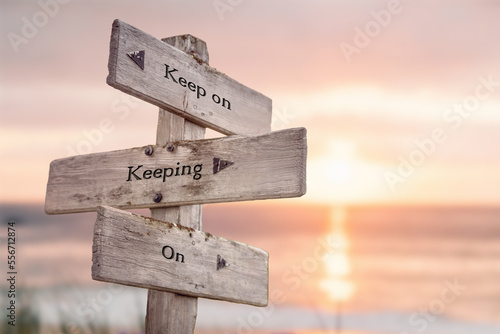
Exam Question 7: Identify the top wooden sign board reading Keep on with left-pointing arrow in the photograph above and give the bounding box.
[107,20,272,135]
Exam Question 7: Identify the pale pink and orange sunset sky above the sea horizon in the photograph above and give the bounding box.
[0,0,500,204]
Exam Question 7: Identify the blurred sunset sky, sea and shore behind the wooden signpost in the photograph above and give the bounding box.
[0,0,500,334]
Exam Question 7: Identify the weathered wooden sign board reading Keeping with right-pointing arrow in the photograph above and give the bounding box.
[45,128,307,214]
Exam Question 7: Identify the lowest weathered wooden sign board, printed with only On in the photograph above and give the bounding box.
[92,207,269,306]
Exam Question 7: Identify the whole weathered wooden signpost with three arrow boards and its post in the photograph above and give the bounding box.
[45,20,307,334]
